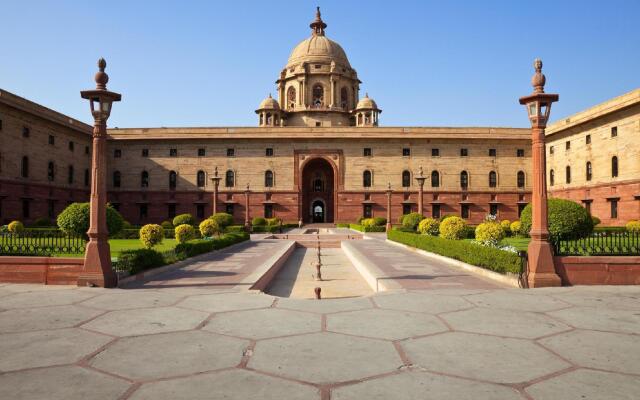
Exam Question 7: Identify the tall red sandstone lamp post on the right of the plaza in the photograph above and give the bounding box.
[520,59,562,287]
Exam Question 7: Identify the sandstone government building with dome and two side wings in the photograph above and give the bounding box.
[0,11,640,225]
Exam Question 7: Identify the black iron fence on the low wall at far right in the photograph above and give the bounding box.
[552,231,640,256]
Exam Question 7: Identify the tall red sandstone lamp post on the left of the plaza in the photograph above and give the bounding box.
[78,58,122,287]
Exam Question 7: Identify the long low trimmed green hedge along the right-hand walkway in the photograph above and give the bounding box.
[387,230,521,274]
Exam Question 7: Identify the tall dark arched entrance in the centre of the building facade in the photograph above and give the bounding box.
[301,158,335,223]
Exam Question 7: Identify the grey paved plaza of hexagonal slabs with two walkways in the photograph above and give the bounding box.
[0,236,640,400]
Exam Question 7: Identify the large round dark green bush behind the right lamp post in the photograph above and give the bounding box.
[520,199,593,239]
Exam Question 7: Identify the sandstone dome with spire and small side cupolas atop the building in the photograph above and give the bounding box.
[256,7,381,126]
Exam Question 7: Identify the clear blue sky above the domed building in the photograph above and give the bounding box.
[0,0,640,127]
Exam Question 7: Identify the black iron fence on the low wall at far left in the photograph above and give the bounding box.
[0,230,87,256]
